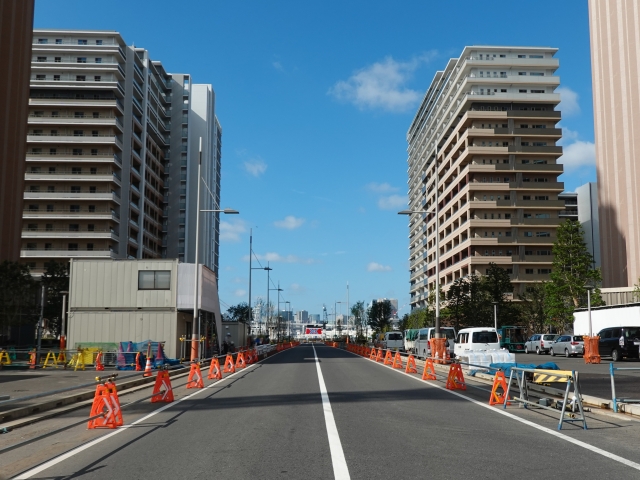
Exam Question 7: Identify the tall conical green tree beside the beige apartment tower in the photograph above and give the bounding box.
[545,220,604,332]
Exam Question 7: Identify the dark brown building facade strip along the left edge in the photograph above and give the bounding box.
[0,0,35,262]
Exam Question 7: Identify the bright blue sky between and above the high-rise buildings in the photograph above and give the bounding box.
[35,0,595,320]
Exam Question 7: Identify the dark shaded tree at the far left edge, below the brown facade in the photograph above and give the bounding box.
[0,260,38,341]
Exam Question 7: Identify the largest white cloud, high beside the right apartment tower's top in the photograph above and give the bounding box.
[328,53,435,112]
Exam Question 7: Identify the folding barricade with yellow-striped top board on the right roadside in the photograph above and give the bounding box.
[503,367,587,430]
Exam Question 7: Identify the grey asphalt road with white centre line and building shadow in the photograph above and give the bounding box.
[0,346,640,480]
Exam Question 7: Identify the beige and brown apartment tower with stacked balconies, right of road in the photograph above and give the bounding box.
[407,46,564,308]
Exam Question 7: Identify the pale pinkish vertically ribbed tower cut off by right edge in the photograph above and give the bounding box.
[589,0,640,287]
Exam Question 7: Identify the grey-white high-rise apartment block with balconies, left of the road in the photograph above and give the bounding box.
[21,30,220,275]
